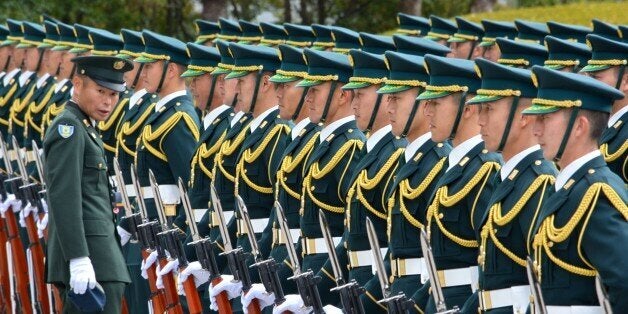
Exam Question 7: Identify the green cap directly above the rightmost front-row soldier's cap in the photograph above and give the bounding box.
[544,35,591,72]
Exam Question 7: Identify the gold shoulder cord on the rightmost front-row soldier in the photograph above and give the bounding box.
[533,182,628,277]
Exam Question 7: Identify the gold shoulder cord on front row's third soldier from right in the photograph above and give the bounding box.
[427,162,500,248]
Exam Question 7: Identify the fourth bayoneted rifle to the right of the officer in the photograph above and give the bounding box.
[170,178,203,314]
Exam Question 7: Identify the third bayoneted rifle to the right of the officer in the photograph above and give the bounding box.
[148,169,183,314]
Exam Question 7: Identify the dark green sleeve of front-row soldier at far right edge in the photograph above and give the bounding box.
[580,193,628,313]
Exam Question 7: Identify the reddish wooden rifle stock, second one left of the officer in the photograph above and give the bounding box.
[5,206,33,314]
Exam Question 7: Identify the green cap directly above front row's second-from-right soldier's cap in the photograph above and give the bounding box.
[495,38,548,69]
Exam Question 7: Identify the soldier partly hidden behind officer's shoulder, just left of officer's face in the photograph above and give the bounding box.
[41,22,76,134]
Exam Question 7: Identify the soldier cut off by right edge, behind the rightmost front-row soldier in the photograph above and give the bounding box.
[581,34,628,183]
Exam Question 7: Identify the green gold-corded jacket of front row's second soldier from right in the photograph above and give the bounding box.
[478,149,556,290]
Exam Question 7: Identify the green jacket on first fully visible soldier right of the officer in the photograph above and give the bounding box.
[135,95,200,222]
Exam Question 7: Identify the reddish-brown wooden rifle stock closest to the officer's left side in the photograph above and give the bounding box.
[24,215,50,313]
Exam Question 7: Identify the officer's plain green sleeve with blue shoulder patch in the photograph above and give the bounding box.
[44,119,89,261]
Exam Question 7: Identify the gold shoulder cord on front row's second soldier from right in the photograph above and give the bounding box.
[478,174,555,267]
